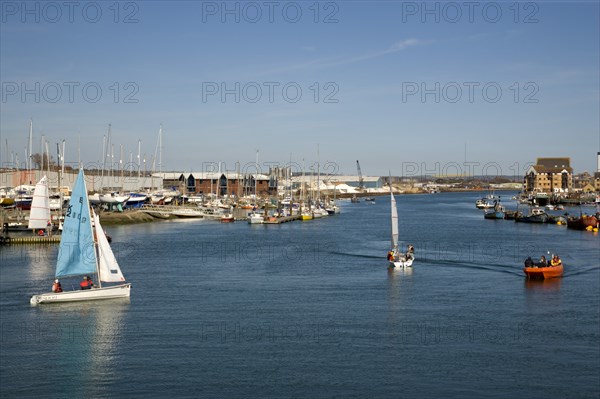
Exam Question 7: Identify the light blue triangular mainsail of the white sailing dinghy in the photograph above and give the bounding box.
[55,169,97,277]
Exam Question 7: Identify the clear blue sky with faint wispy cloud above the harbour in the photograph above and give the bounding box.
[0,1,600,176]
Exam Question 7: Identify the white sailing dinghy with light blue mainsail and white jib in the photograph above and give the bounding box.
[30,169,131,305]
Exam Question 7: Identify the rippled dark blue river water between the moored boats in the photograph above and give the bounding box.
[0,193,600,398]
